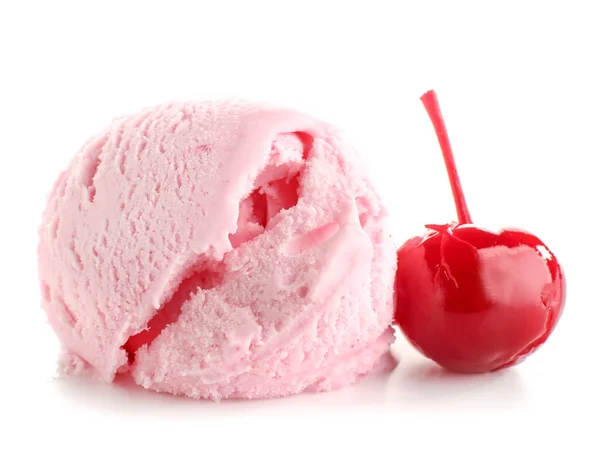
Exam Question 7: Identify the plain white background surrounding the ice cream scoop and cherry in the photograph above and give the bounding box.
[0,0,600,461]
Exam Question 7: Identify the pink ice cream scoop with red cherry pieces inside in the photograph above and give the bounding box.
[39,102,396,400]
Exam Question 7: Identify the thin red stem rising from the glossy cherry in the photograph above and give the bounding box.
[421,90,472,225]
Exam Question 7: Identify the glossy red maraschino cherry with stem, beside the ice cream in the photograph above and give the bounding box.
[395,91,566,373]
